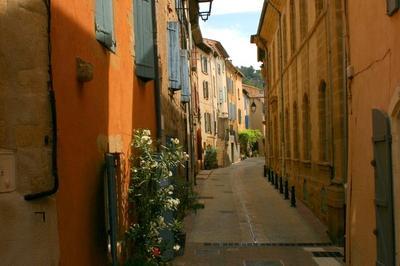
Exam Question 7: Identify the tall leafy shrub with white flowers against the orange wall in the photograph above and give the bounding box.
[127,129,189,265]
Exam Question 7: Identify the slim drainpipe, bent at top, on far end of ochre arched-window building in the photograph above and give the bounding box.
[268,1,287,180]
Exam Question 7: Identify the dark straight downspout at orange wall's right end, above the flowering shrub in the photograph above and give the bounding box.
[151,0,162,144]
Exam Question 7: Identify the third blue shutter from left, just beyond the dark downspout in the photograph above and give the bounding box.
[168,21,181,90]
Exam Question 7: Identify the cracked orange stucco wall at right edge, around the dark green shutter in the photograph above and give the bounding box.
[347,0,400,265]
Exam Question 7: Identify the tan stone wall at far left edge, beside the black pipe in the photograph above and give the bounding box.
[0,0,59,265]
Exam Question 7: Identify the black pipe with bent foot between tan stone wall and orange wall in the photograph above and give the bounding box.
[24,0,59,201]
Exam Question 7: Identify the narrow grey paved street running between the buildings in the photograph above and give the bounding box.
[174,158,343,266]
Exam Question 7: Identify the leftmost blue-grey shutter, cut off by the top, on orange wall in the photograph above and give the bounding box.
[95,0,115,52]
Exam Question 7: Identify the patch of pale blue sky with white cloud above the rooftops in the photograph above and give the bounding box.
[200,0,264,69]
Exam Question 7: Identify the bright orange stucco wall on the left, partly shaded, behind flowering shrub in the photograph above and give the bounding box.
[51,0,155,265]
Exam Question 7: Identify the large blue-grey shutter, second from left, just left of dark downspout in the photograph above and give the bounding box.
[134,0,155,79]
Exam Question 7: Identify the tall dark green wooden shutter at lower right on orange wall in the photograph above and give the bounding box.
[372,109,395,266]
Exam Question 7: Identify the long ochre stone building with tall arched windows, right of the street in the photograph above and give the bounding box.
[252,0,347,244]
